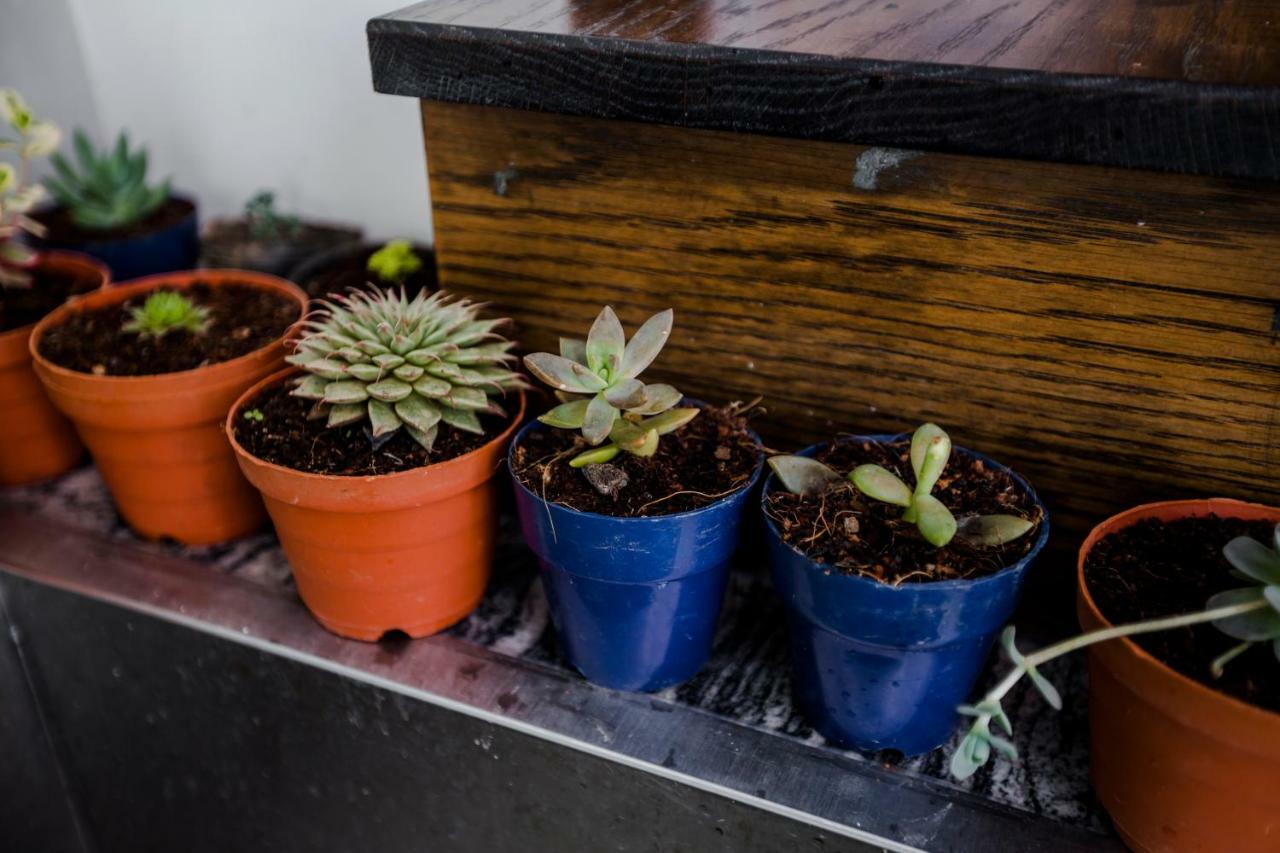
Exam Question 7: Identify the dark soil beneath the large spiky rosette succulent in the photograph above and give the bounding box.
[236,379,511,476]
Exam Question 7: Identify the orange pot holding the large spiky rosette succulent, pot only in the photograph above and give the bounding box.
[227,369,525,640]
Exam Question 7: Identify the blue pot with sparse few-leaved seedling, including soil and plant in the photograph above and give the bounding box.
[763,424,1048,756]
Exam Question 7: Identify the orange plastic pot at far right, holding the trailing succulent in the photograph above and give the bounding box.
[1076,498,1280,853]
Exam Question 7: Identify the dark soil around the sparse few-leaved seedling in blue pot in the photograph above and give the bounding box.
[765,439,1041,585]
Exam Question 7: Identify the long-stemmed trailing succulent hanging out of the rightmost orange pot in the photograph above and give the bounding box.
[951,517,1280,779]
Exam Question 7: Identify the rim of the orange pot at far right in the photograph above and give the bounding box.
[1075,498,1280,725]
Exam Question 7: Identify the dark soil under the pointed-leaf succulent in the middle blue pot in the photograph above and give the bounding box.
[515,406,762,517]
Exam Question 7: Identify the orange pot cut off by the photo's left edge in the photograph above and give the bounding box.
[0,252,110,485]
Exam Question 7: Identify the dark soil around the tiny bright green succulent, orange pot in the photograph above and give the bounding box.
[40,282,300,377]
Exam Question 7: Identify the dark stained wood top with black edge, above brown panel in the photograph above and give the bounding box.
[369,0,1280,178]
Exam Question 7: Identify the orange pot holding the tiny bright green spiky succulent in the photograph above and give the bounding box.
[31,269,307,544]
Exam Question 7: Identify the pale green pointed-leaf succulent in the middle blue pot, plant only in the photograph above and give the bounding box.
[525,306,698,467]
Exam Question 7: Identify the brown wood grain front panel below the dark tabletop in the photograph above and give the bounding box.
[424,104,1280,571]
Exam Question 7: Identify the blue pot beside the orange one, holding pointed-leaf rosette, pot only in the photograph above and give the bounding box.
[508,421,763,692]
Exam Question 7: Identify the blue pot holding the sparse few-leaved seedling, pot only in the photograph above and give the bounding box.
[762,435,1048,756]
